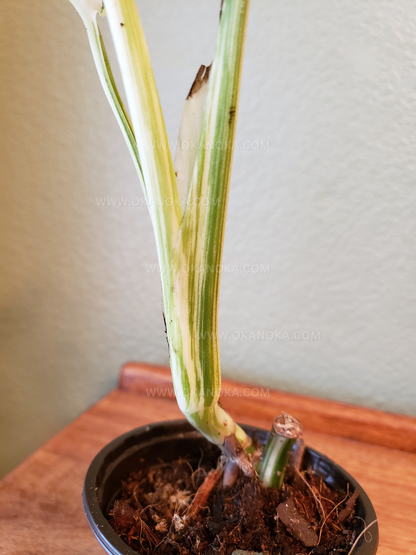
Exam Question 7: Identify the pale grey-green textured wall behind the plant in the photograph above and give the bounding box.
[0,0,416,478]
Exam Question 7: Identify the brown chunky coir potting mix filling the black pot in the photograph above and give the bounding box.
[108,450,363,555]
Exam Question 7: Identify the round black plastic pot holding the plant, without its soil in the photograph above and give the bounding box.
[83,420,378,555]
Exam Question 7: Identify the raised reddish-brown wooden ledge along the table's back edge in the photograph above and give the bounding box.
[120,362,416,456]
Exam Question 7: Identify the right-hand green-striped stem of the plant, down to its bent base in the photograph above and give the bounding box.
[167,0,250,452]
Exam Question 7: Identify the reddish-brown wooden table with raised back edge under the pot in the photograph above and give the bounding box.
[0,363,416,555]
